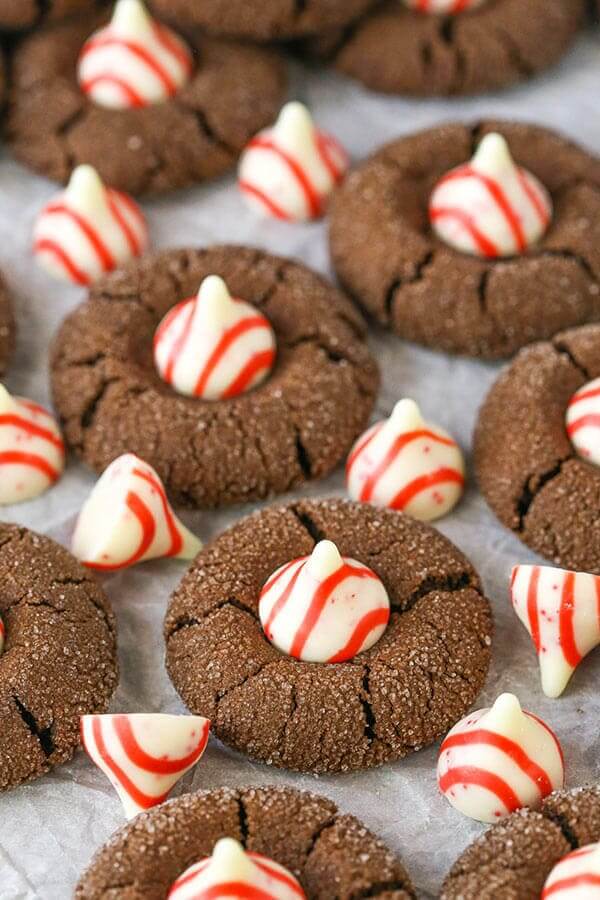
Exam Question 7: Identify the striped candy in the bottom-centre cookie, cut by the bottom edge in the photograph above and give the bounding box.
[169,838,306,900]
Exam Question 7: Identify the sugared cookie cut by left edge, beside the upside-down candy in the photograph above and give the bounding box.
[0,523,117,790]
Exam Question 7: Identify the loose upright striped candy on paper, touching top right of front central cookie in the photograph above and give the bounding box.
[346,400,465,522]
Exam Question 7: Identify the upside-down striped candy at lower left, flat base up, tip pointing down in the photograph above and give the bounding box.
[81,713,210,819]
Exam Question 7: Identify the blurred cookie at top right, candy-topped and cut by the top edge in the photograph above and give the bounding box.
[308,0,585,96]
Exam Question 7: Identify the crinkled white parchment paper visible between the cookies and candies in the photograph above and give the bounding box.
[0,32,600,900]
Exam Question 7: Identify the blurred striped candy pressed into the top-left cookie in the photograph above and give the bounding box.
[77,0,193,109]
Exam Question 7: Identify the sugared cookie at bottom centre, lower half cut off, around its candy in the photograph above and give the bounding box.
[75,787,416,900]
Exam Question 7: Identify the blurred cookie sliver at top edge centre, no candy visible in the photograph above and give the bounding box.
[152,0,375,41]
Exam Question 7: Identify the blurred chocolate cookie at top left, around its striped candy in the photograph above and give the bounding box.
[7,16,286,194]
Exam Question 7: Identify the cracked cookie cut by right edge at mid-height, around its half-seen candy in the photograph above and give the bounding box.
[475,325,600,575]
